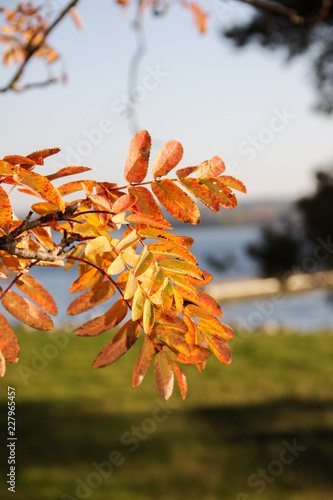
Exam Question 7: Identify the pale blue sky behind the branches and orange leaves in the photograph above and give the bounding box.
[0,0,333,208]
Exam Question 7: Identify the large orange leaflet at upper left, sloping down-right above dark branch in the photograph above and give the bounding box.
[13,167,65,212]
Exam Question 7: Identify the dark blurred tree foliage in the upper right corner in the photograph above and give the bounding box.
[223,0,333,113]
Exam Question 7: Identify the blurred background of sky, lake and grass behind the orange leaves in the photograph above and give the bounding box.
[0,0,333,500]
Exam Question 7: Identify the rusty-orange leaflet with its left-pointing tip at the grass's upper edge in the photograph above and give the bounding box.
[74,297,127,337]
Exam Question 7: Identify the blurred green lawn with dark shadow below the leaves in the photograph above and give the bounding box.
[0,330,333,500]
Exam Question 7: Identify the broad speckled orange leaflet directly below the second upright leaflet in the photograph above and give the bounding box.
[151,179,200,224]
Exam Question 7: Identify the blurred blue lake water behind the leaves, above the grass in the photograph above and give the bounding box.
[6,225,333,332]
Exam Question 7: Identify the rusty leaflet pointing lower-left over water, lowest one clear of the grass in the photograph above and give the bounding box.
[67,281,116,315]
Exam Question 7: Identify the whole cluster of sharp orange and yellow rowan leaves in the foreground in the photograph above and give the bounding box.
[0,131,246,398]
